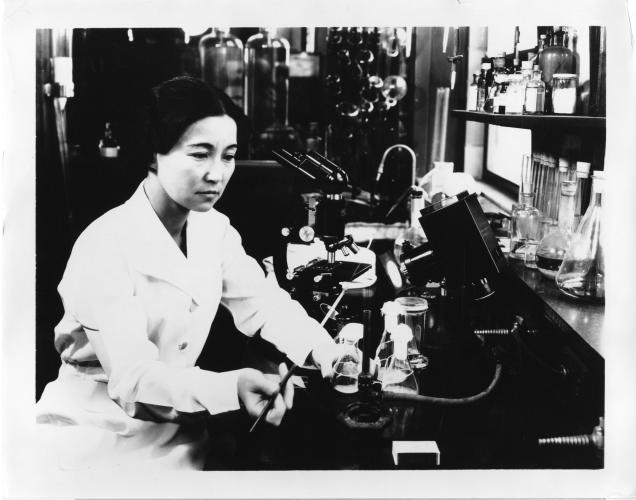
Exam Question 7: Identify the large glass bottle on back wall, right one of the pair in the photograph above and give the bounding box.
[245,28,298,157]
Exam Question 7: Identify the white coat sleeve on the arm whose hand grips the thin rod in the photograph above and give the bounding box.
[59,230,241,421]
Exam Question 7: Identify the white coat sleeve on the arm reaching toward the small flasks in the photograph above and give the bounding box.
[222,222,333,365]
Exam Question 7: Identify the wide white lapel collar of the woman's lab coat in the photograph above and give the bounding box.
[124,181,218,305]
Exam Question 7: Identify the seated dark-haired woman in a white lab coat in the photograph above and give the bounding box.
[37,77,337,469]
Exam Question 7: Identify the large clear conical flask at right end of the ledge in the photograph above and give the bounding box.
[556,176,605,302]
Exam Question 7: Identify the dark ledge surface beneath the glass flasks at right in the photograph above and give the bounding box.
[510,261,605,357]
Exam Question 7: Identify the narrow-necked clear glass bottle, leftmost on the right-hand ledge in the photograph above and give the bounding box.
[508,155,541,267]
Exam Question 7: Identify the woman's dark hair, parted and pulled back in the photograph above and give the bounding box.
[146,76,247,169]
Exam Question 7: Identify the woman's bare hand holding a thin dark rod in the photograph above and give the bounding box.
[238,363,294,425]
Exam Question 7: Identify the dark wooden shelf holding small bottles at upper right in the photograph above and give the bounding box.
[451,109,605,130]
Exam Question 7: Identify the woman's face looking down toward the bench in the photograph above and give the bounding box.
[157,115,237,212]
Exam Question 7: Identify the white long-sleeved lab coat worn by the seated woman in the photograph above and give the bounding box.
[36,183,333,468]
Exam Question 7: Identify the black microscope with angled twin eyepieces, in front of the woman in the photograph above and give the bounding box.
[272,149,372,328]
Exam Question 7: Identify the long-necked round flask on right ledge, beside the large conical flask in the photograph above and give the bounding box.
[536,168,577,279]
